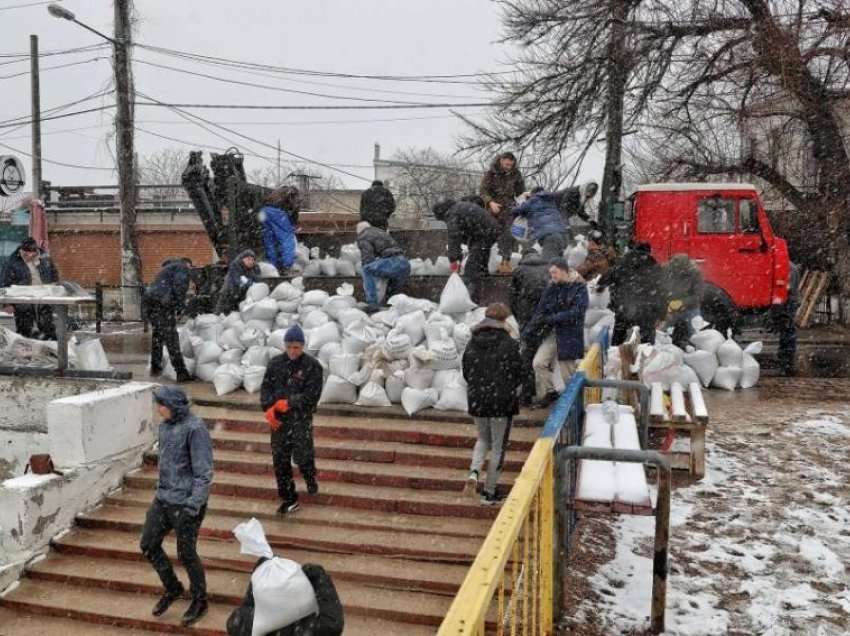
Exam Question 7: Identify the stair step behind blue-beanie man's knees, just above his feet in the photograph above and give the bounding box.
[212,429,526,472]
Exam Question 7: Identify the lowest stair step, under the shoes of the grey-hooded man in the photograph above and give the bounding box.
[0,579,433,636]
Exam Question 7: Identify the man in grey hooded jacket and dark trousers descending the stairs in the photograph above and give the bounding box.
[140,386,213,626]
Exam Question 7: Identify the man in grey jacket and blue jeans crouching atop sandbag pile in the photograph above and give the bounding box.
[357,221,410,313]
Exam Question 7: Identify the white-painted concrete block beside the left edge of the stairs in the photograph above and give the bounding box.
[47,382,157,470]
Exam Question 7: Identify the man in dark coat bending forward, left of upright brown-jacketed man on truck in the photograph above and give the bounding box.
[433,199,501,303]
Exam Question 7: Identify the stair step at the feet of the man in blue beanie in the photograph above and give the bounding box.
[124,468,498,519]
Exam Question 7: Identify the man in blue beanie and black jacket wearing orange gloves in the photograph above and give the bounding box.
[260,325,324,514]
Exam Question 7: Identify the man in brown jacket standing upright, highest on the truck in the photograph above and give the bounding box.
[479,152,525,274]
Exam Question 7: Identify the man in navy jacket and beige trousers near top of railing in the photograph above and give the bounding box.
[522,258,588,408]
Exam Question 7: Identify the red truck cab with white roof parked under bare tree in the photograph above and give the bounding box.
[632,183,790,324]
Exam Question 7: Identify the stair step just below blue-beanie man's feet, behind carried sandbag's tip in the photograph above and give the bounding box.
[77,506,481,564]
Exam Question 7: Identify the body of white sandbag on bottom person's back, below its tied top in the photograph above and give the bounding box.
[251,557,319,636]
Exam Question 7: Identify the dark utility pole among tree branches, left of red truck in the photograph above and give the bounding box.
[599,0,629,237]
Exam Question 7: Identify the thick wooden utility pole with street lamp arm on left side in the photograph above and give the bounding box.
[113,0,142,320]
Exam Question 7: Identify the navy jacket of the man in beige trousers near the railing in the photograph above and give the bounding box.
[522,271,588,360]
